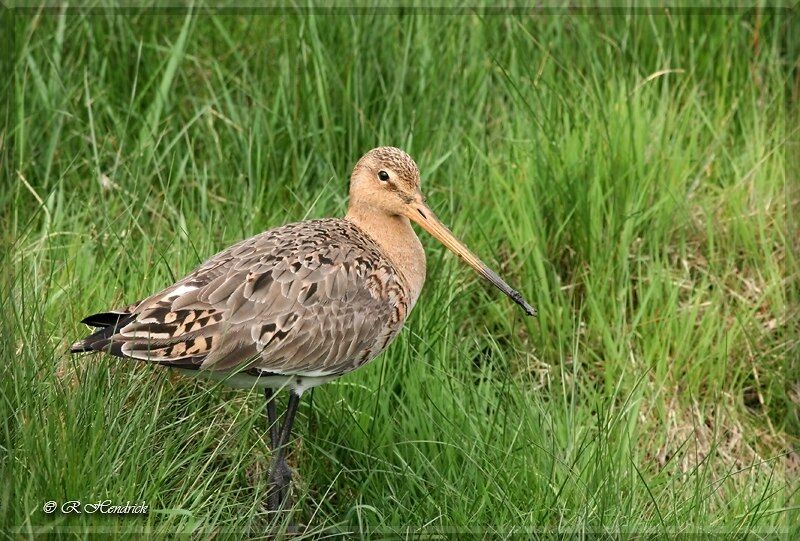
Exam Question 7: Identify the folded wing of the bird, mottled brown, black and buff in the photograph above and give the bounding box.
[90,220,407,375]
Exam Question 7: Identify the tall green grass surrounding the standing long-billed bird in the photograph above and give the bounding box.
[0,4,800,537]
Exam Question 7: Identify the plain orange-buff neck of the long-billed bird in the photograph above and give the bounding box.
[344,205,425,311]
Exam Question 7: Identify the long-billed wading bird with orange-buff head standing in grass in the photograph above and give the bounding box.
[70,146,536,511]
